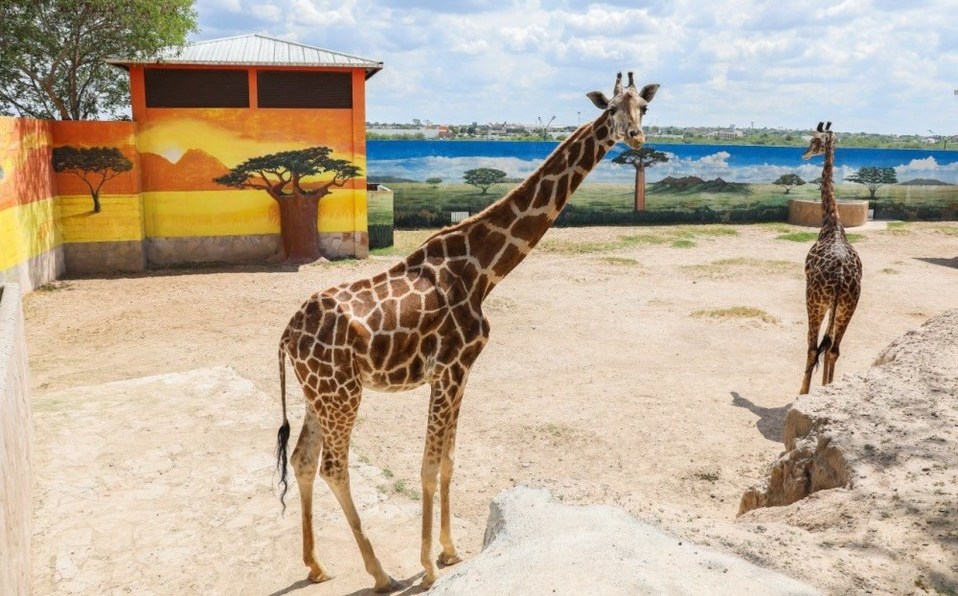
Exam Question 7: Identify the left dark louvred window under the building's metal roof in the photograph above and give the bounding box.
[144,68,249,108]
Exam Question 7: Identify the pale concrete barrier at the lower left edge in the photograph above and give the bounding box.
[0,284,33,594]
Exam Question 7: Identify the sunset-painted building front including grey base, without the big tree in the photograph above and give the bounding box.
[131,67,369,264]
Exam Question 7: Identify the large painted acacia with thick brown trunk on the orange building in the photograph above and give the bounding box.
[213,147,361,261]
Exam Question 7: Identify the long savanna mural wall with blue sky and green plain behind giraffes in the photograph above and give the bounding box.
[366,140,958,229]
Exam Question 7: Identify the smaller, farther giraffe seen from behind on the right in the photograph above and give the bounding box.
[799,122,862,395]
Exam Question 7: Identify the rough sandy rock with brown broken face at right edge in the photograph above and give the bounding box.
[738,310,958,515]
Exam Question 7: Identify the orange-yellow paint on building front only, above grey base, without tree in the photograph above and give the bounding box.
[130,65,367,236]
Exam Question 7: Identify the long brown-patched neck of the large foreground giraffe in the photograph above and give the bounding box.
[424,112,616,298]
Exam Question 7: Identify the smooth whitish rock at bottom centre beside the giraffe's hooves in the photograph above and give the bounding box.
[430,486,818,596]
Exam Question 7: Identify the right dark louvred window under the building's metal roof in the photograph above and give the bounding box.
[256,70,353,108]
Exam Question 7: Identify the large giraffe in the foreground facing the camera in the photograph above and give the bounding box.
[277,72,659,592]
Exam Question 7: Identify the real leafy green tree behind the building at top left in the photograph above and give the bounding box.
[0,0,197,120]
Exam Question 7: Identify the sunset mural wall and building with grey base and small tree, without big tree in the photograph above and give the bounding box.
[0,70,369,291]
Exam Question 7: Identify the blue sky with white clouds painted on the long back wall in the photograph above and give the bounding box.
[366,141,958,184]
